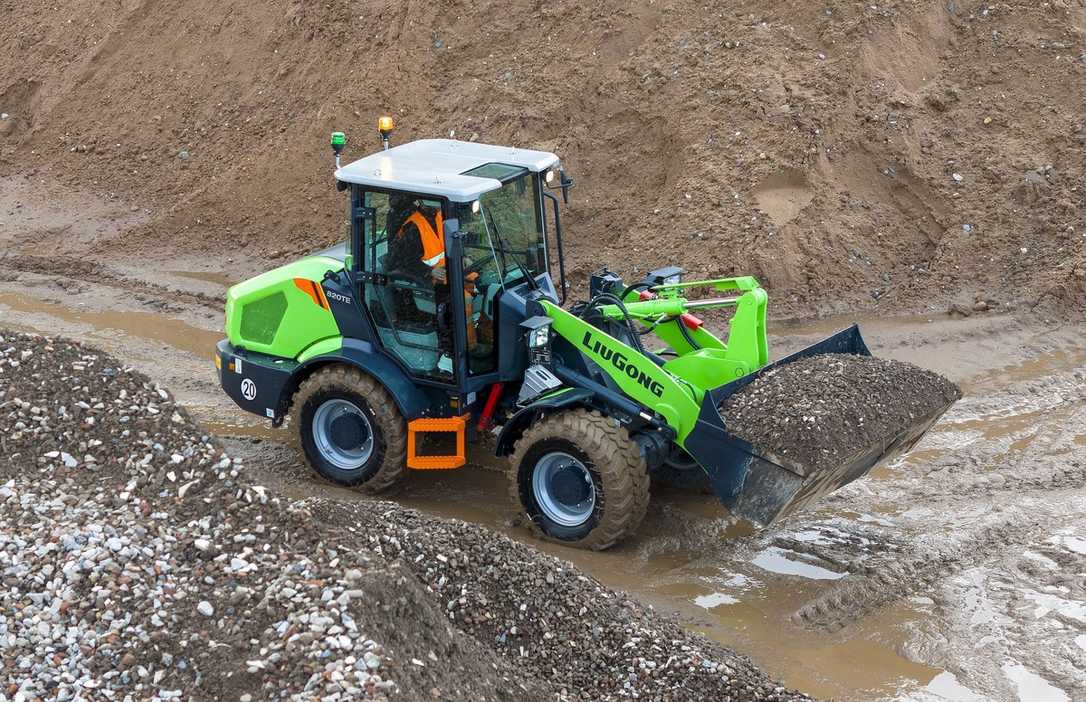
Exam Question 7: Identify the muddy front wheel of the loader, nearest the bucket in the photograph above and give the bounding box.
[509,410,648,551]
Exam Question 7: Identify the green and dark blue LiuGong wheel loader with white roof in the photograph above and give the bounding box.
[215,118,960,549]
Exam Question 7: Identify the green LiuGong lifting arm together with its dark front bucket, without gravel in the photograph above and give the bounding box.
[543,277,949,525]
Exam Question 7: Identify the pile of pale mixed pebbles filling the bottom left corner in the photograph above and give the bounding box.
[0,333,543,701]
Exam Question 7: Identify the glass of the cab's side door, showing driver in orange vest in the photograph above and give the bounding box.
[362,191,455,380]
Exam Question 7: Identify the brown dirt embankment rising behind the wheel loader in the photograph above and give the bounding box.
[0,0,1086,316]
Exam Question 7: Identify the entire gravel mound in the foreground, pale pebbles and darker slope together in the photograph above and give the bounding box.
[0,333,806,701]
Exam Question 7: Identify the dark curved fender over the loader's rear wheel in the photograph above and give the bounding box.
[280,339,432,421]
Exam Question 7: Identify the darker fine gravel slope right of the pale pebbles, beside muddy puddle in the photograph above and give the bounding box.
[303,499,808,701]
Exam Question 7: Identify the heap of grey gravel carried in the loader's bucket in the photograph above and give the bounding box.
[720,353,961,468]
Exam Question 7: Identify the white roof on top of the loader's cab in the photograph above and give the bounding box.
[336,139,558,202]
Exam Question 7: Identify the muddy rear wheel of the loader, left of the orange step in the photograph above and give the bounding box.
[290,365,407,492]
